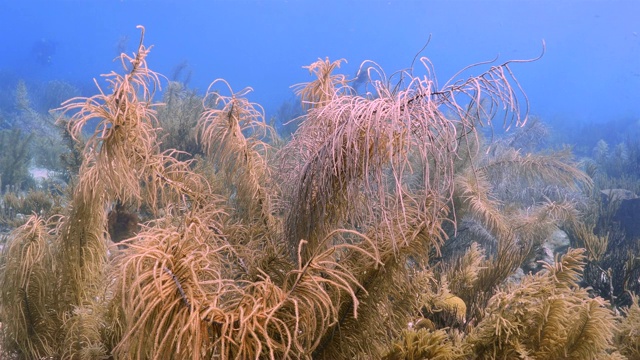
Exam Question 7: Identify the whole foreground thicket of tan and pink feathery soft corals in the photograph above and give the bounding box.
[0,28,639,359]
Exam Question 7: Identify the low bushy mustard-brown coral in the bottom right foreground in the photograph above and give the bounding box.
[467,250,615,359]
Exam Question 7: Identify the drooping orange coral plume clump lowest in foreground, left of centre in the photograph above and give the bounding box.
[112,204,239,359]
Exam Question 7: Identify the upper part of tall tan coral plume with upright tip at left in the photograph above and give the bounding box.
[61,28,164,208]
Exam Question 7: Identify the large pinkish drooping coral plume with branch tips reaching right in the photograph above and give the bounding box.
[281,50,532,262]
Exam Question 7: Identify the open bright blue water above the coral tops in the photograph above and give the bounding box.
[0,0,640,129]
